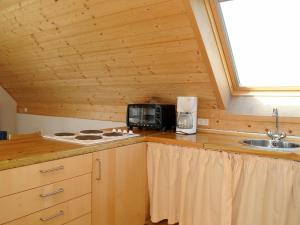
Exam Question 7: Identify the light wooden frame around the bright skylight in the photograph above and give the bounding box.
[204,0,300,95]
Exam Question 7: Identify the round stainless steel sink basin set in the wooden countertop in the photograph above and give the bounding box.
[241,139,300,152]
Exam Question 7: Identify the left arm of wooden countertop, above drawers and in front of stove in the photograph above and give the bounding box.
[0,135,144,171]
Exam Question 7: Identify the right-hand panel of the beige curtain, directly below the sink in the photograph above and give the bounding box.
[231,155,300,225]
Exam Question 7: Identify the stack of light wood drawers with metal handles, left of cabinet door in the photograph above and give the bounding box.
[0,154,92,225]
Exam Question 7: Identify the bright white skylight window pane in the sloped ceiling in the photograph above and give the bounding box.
[216,0,300,90]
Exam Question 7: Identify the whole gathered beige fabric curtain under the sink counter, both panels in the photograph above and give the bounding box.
[148,143,300,225]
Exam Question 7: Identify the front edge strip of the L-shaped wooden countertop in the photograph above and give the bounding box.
[0,134,300,171]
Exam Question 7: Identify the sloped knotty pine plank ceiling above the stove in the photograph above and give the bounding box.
[0,0,219,121]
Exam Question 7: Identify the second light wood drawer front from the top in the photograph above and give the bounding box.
[0,174,91,224]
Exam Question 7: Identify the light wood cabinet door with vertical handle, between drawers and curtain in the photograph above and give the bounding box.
[92,143,148,225]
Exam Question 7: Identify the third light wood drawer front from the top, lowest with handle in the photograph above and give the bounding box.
[5,194,91,225]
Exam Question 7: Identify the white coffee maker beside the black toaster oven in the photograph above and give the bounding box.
[176,97,198,134]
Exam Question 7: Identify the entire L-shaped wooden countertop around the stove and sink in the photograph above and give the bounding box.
[0,131,300,170]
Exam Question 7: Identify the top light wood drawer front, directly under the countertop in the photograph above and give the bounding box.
[0,154,92,197]
